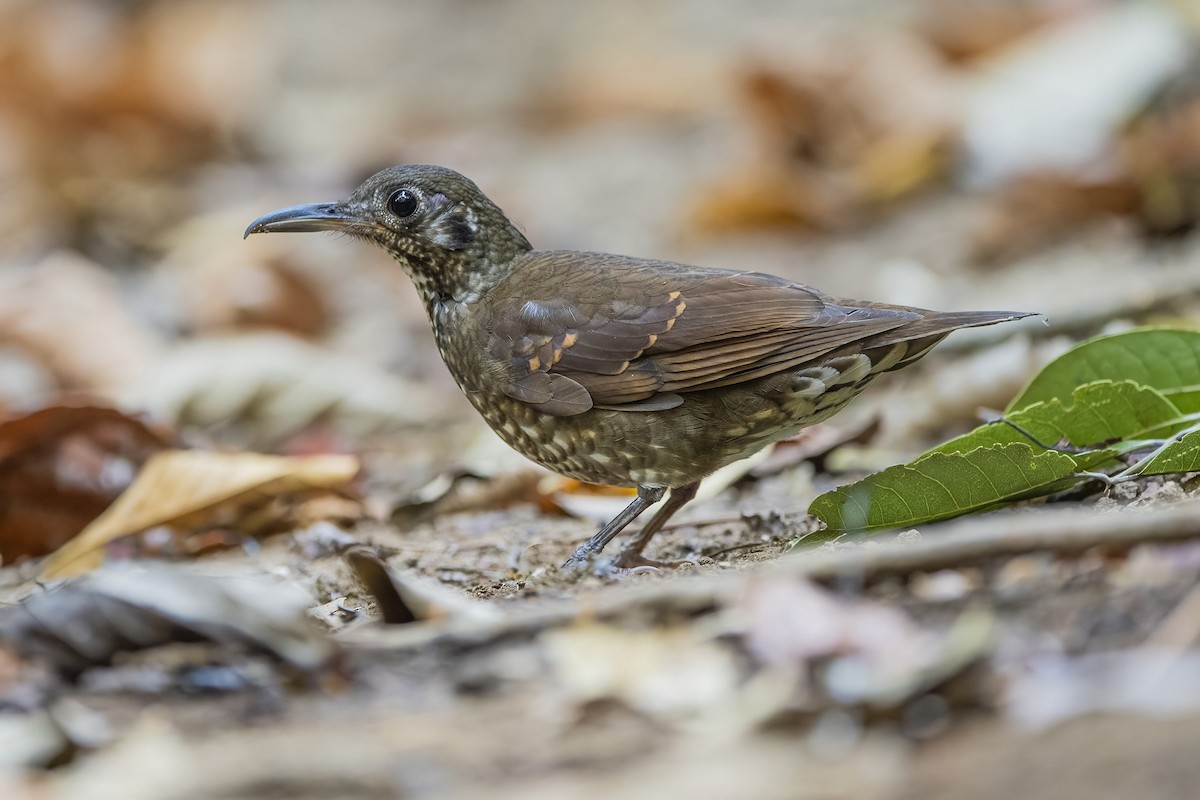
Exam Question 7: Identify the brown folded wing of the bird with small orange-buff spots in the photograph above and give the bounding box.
[487,252,923,416]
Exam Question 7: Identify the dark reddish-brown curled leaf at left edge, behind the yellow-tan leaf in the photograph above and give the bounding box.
[0,405,169,563]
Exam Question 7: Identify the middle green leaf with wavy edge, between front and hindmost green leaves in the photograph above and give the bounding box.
[931,380,1186,461]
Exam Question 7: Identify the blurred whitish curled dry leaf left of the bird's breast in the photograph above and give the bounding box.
[124,333,445,445]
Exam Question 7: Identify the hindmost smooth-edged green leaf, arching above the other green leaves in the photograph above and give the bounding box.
[1007,327,1200,414]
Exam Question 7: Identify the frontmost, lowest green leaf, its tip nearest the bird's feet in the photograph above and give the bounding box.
[809,443,1112,531]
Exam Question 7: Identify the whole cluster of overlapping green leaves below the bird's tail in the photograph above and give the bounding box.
[805,329,1200,540]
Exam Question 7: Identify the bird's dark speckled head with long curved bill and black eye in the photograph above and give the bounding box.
[246,164,530,296]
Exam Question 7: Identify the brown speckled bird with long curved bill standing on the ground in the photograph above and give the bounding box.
[245,164,1030,570]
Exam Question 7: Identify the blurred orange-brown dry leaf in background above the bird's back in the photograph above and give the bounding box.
[692,40,956,233]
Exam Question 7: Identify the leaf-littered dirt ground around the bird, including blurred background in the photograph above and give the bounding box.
[0,0,1200,800]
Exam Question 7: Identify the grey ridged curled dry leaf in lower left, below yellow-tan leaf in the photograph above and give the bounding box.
[0,566,331,675]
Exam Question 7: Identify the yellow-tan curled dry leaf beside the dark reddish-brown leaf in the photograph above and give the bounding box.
[43,450,359,578]
